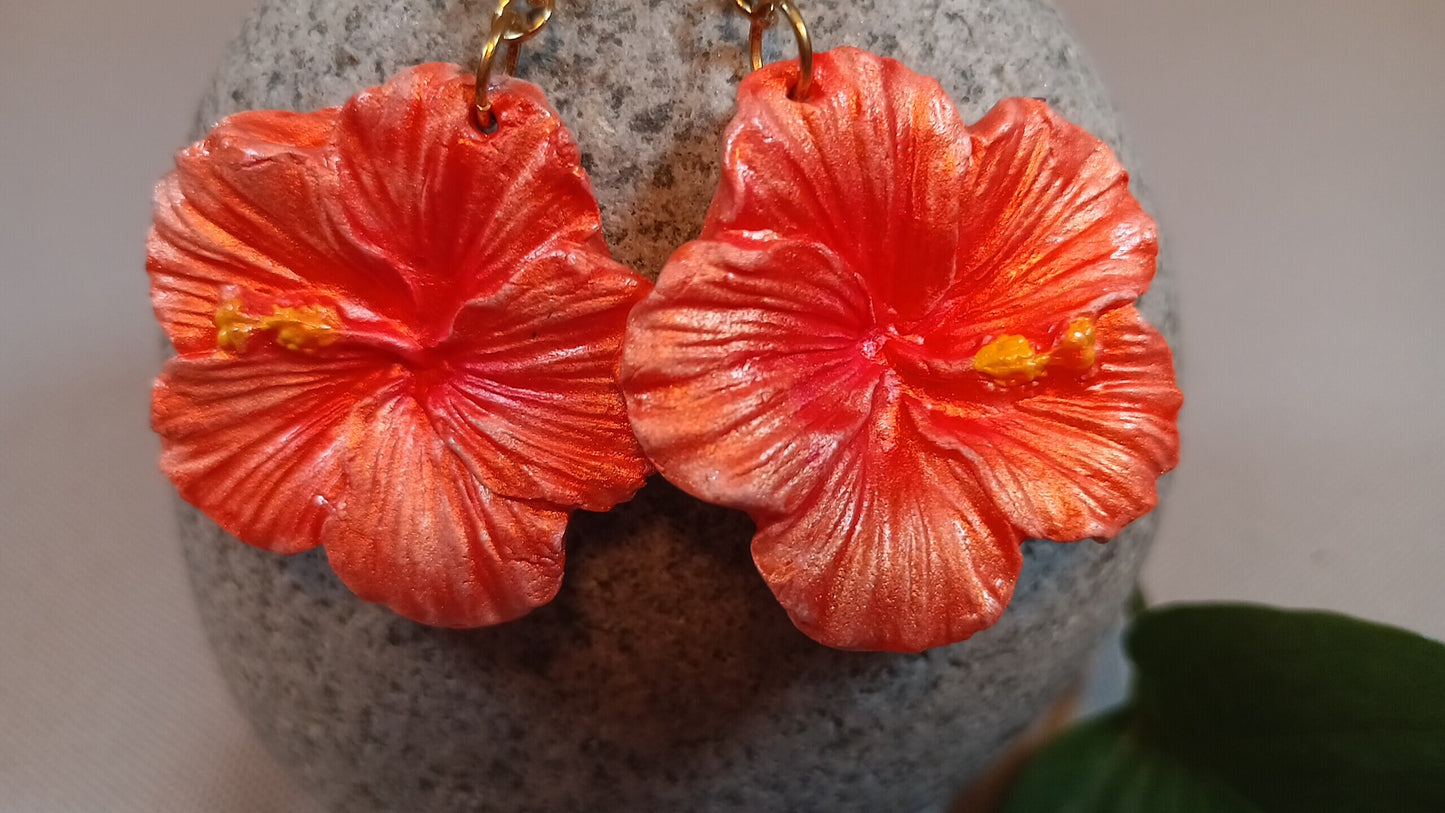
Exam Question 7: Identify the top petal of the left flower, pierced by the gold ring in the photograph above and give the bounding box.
[335,64,605,329]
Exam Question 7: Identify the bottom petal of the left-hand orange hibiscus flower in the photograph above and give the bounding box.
[325,387,566,628]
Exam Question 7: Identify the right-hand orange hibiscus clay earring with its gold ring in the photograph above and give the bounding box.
[623,0,1182,651]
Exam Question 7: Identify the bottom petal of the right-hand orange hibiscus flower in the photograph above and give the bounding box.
[753,397,1023,653]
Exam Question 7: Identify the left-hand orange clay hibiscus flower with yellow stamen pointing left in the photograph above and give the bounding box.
[147,64,650,627]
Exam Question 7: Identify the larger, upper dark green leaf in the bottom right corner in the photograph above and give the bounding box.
[1129,605,1445,813]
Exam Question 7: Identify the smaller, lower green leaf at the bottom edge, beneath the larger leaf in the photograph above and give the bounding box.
[1004,712,1260,813]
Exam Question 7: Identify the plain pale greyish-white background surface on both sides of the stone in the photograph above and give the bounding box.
[0,0,1445,813]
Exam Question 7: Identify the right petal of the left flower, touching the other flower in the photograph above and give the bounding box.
[428,245,652,511]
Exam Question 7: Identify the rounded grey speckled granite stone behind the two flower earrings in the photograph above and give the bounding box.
[181,0,1173,813]
